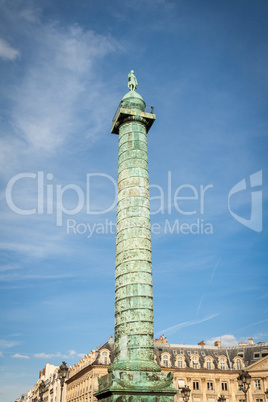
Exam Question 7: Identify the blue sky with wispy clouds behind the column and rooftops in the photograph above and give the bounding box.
[0,0,268,402]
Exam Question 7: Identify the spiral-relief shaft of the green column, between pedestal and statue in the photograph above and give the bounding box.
[113,74,160,371]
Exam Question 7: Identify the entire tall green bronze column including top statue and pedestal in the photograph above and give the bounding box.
[96,71,177,402]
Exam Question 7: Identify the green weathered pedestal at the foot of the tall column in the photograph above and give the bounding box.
[95,370,178,402]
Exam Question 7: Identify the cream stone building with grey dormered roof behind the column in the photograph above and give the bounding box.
[66,337,268,402]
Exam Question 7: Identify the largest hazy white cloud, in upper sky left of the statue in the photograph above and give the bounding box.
[10,24,116,152]
